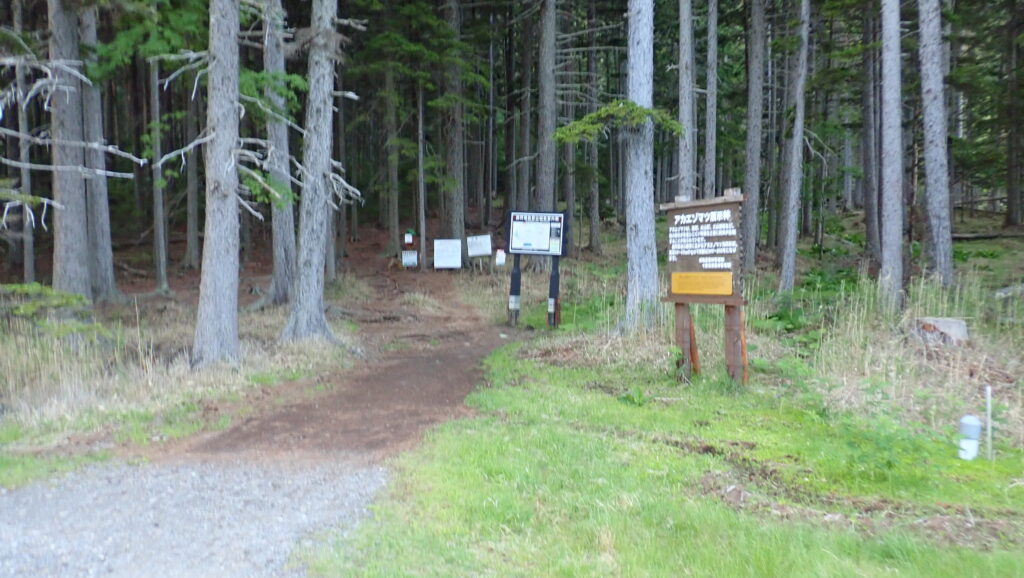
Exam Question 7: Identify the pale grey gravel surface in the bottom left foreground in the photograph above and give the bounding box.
[0,463,386,578]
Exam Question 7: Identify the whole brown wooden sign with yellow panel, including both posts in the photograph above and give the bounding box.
[660,195,748,383]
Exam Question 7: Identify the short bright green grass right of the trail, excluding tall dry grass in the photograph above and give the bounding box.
[299,346,1024,576]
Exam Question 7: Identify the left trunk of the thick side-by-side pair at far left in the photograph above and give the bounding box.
[48,0,92,300]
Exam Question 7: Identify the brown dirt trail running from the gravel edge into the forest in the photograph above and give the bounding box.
[142,228,510,464]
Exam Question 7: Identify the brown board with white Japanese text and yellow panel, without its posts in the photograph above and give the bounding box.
[662,196,743,297]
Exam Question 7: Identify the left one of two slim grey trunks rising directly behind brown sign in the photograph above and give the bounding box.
[678,0,697,201]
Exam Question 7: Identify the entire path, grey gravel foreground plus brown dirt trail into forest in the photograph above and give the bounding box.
[0,232,510,577]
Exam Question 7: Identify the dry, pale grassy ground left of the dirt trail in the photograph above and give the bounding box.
[0,278,370,488]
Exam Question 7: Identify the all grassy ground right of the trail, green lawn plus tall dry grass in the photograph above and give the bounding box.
[298,214,1024,576]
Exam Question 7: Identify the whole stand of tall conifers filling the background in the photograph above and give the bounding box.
[0,0,1022,364]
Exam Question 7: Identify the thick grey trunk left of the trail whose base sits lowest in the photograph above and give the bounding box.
[191,0,239,366]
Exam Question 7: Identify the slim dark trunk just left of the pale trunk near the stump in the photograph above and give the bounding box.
[860,11,882,263]
